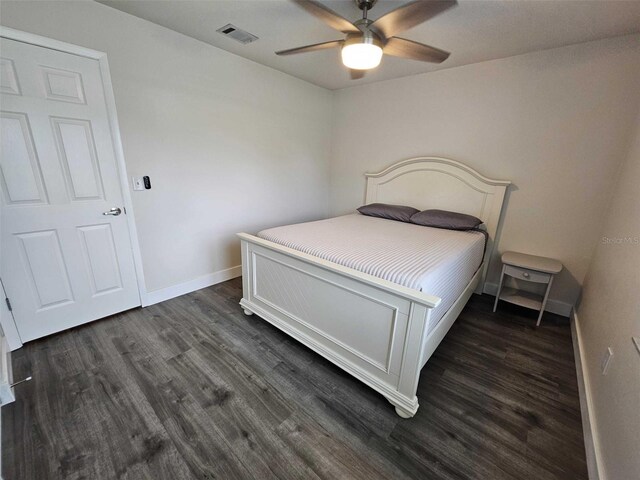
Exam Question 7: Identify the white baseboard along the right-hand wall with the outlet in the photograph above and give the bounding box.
[571,310,605,480]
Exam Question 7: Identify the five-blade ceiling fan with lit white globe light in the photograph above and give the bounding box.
[276,0,457,80]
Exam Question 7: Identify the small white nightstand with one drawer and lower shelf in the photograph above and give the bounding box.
[493,252,562,327]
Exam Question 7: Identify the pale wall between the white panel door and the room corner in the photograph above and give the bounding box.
[0,1,332,291]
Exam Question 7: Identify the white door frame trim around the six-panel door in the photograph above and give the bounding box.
[0,26,147,351]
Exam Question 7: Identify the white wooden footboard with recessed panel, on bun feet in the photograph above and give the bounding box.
[239,234,440,417]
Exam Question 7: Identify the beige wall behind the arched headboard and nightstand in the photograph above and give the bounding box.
[331,35,640,314]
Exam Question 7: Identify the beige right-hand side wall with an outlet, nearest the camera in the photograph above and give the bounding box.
[577,110,640,480]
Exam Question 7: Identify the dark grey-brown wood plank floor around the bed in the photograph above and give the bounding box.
[2,279,587,480]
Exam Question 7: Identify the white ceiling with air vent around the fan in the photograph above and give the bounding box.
[100,0,640,89]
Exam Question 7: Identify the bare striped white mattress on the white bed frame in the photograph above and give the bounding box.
[258,213,485,331]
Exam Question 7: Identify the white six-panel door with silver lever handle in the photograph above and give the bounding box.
[0,39,140,342]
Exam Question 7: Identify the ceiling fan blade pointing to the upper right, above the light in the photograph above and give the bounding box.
[371,0,458,38]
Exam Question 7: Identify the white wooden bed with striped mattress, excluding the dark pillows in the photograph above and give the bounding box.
[238,157,510,418]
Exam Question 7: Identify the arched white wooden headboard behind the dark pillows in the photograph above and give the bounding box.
[365,157,511,288]
